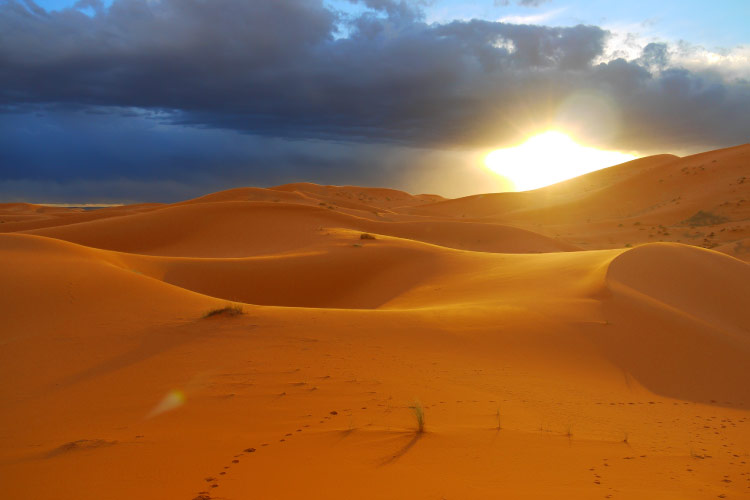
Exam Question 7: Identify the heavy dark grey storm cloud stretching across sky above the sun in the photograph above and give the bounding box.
[0,0,750,150]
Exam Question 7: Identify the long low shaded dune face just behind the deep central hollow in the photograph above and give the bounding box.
[22,201,576,257]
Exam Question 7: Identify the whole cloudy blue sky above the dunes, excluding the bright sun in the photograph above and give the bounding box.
[0,0,750,203]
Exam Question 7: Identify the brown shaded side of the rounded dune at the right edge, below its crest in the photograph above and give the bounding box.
[591,243,750,406]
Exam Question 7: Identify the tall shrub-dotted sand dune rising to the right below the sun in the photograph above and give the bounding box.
[412,145,750,249]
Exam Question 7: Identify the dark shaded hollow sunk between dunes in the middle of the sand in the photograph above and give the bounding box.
[131,240,444,309]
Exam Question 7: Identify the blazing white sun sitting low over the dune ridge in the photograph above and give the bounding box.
[484,130,637,191]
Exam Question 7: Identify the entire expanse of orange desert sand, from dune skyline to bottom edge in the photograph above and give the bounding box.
[0,146,750,500]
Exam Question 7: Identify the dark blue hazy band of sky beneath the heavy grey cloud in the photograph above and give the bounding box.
[0,109,502,203]
